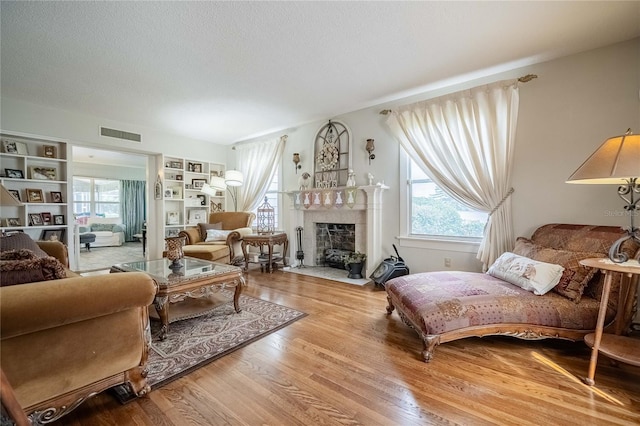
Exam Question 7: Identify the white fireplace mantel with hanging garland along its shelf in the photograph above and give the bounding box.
[287,184,389,277]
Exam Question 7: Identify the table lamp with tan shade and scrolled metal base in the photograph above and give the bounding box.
[567,129,640,263]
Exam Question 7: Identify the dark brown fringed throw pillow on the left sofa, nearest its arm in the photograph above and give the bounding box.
[0,253,67,287]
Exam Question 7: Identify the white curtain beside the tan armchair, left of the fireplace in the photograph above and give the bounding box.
[236,135,287,212]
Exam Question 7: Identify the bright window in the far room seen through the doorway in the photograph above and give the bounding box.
[73,176,120,223]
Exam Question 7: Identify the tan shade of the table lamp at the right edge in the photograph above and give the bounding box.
[567,132,640,185]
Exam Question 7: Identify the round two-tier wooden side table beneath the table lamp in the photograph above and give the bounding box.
[580,258,640,386]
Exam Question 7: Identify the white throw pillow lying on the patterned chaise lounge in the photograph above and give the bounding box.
[487,252,564,296]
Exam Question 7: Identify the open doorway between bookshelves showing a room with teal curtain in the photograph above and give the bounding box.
[69,146,149,272]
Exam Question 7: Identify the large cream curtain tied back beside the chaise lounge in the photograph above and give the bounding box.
[387,80,519,269]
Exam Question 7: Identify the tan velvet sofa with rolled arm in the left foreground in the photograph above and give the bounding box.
[0,234,156,424]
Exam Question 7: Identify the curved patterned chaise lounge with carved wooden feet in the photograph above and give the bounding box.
[385,224,638,362]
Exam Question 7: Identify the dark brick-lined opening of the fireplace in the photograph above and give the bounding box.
[316,223,356,269]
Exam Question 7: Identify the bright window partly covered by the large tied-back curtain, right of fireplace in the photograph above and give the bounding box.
[408,160,488,238]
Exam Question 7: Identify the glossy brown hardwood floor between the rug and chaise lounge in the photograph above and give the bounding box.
[57,270,640,426]
